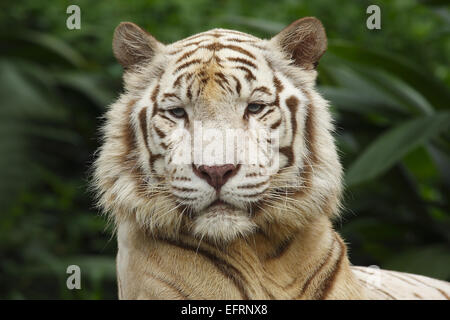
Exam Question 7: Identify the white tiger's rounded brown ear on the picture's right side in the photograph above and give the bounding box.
[270,17,327,70]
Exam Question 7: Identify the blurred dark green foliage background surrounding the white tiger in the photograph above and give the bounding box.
[0,0,450,299]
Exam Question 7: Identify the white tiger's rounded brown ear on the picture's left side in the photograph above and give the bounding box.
[113,22,164,69]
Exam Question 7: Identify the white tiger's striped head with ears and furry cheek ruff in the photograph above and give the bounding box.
[94,18,341,242]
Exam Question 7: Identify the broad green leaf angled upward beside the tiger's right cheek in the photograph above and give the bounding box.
[346,112,450,185]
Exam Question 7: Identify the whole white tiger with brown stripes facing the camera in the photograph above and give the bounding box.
[92,17,450,299]
